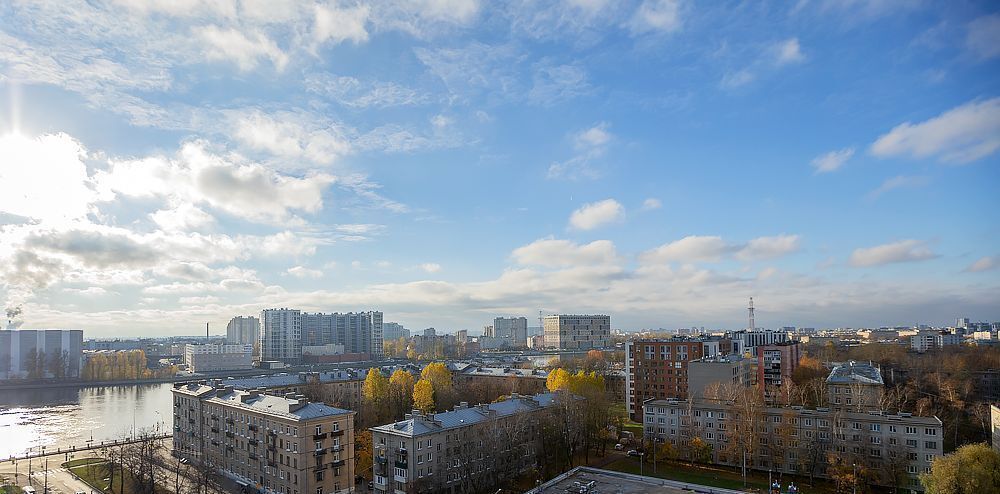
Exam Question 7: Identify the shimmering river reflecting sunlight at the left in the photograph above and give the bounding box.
[0,383,172,459]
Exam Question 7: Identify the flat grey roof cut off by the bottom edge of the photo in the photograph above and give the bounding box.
[527,467,744,494]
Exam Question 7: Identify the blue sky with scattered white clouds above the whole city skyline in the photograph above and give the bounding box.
[0,0,1000,337]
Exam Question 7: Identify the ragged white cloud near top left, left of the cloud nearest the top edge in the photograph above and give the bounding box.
[192,25,288,72]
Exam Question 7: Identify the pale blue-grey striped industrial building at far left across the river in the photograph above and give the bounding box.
[0,329,83,379]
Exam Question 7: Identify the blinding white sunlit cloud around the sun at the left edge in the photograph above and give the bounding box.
[0,134,96,223]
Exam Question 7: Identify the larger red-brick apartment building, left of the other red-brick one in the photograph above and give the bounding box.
[625,336,706,422]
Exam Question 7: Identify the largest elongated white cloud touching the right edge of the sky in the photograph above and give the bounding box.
[871,98,1000,163]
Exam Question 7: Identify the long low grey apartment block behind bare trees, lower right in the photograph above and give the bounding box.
[643,399,944,491]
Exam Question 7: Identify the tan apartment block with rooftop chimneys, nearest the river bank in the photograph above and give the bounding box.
[172,383,355,494]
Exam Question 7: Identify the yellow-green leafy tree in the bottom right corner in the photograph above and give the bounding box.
[920,443,1000,494]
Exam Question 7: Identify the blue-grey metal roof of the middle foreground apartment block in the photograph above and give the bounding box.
[371,393,556,437]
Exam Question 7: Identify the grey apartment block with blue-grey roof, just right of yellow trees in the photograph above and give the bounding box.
[371,393,556,494]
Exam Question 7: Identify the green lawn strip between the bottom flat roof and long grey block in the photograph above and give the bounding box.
[604,458,834,494]
